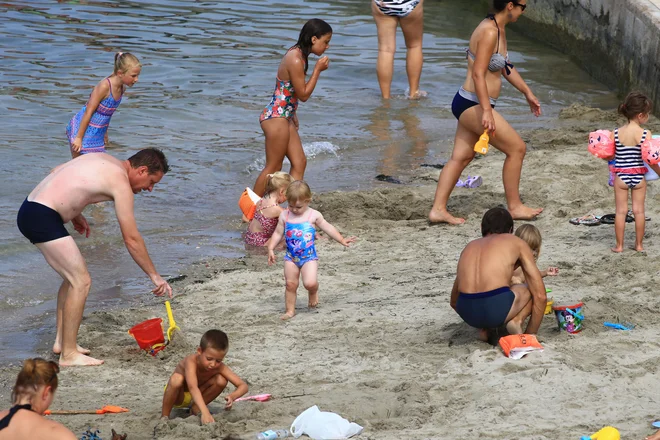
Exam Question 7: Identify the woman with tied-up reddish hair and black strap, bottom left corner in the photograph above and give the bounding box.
[0,358,78,440]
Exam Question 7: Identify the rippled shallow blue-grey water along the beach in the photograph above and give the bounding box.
[0,0,616,362]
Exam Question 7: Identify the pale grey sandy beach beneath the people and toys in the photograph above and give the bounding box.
[0,106,660,440]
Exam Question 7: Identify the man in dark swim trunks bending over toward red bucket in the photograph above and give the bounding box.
[17,148,172,366]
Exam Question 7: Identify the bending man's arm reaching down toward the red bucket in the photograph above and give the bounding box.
[113,180,172,298]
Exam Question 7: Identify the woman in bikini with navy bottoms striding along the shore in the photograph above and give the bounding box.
[429,0,543,224]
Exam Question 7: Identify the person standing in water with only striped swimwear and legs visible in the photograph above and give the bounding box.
[371,0,424,99]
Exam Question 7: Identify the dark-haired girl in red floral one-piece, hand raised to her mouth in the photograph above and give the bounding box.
[254,18,332,196]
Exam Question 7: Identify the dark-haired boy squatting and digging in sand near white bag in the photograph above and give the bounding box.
[161,330,248,424]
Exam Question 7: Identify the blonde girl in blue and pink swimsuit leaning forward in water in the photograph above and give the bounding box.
[66,52,142,158]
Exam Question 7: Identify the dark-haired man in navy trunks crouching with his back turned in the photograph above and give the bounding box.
[451,208,547,340]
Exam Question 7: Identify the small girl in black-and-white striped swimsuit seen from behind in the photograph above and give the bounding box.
[612,92,660,252]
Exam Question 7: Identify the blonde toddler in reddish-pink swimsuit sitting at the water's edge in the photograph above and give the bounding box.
[245,171,293,246]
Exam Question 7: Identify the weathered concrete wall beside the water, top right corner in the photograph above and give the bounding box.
[515,0,660,113]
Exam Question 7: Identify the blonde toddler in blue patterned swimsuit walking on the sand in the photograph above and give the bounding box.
[268,180,357,319]
